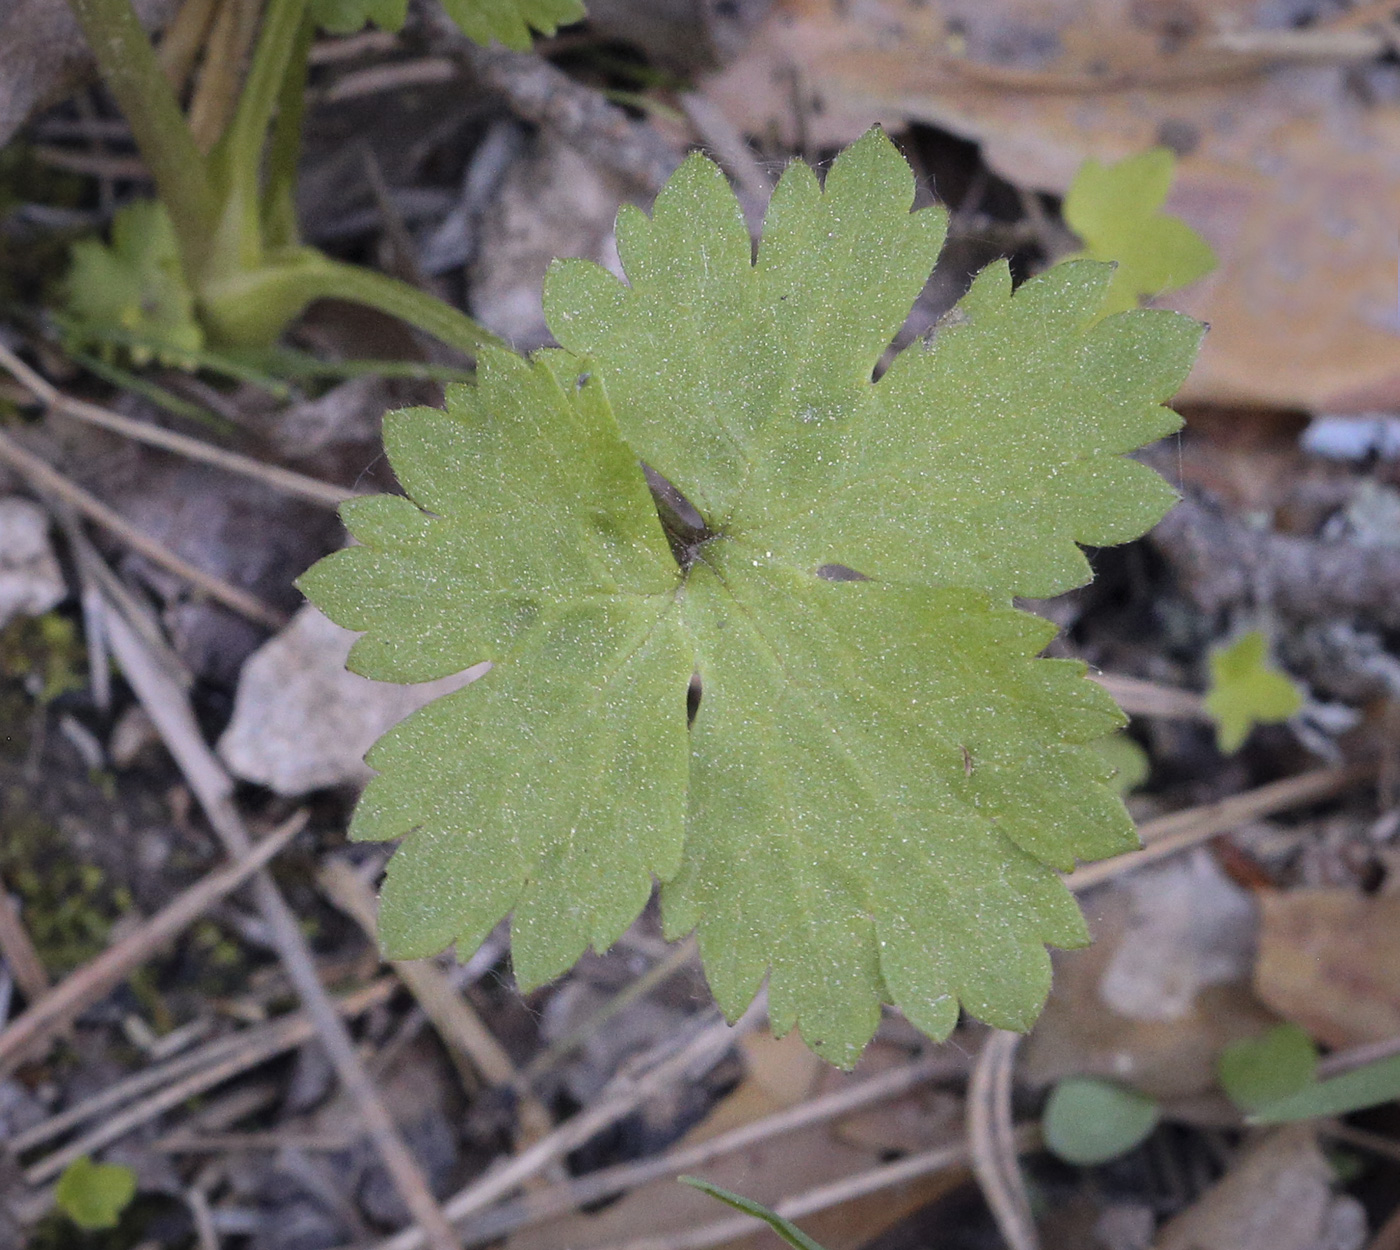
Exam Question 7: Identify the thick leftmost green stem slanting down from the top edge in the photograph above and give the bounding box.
[70,0,218,276]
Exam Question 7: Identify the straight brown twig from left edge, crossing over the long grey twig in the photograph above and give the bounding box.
[0,812,307,1072]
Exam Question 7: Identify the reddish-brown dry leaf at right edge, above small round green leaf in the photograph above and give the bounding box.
[1254,889,1400,1046]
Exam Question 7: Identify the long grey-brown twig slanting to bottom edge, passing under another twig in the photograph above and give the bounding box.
[106,596,456,1250]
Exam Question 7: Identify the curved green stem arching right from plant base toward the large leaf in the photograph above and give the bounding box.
[200,248,505,356]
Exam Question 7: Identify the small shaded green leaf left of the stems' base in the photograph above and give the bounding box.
[66,200,204,365]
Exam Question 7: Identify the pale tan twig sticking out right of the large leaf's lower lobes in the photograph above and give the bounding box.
[1064,764,1376,890]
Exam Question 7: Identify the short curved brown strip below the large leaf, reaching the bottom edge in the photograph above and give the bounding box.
[967,1029,1040,1250]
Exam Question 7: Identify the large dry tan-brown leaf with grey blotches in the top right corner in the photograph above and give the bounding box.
[706,0,1400,412]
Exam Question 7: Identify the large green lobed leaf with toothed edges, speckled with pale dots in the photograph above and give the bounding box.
[304,132,1200,1064]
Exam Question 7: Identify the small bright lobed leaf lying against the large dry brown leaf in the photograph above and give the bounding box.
[1064,147,1215,315]
